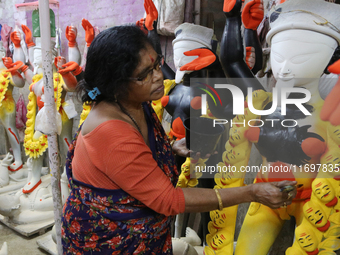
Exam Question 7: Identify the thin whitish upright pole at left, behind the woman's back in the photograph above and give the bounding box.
[39,0,63,255]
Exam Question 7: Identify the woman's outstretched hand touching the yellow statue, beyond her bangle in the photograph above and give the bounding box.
[252,181,297,209]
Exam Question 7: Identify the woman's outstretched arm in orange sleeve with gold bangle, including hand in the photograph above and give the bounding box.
[101,122,296,215]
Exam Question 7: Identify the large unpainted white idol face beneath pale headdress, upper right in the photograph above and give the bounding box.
[270,29,337,86]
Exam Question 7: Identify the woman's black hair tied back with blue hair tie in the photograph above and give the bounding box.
[77,25,152,103]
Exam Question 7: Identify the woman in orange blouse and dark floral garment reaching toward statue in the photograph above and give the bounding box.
[62,26,296,254]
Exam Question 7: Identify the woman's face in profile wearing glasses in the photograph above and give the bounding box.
[128,45,164,102]
